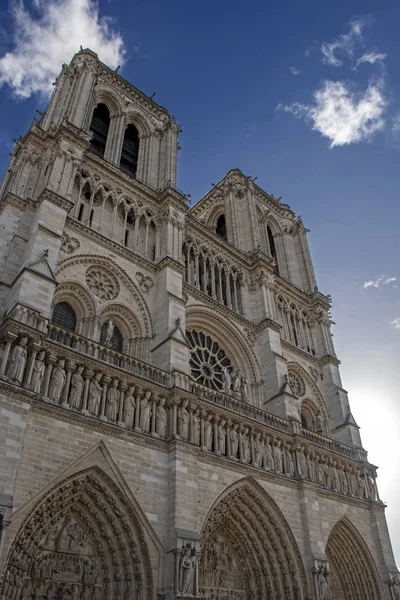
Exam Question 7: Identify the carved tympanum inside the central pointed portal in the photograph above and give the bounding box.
[200,533,247,600]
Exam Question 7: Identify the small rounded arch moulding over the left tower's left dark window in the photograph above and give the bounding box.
[53,280,97,335]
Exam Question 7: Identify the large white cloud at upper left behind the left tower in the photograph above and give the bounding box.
[0,0,125,99]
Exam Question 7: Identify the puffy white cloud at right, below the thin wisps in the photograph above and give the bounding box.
[277,80,387,148]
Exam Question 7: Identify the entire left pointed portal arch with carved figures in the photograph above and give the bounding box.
[0,466,153,600]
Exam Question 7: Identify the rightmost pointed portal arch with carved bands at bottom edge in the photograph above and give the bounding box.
[326,517,383,600]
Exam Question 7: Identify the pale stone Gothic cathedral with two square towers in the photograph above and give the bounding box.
[0,50,400,600]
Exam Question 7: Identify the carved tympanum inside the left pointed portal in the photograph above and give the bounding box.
[20,515,103,600]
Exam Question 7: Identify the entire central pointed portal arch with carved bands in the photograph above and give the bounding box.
[199,478,307,600]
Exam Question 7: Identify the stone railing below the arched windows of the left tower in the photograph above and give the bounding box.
[48,323,170,386]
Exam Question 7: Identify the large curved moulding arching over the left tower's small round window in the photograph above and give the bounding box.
[58,254,154,338]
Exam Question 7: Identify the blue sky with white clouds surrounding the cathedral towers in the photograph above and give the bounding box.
[0,0,400,563]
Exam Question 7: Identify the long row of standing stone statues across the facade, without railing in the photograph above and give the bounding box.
[2,338,378,500]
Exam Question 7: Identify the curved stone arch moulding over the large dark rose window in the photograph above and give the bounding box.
[186,304,261,383]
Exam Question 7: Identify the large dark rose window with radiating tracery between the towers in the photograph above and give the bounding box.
[186,330,231,390]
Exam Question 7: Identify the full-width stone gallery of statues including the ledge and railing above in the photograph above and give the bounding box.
[0,329,379,501]
